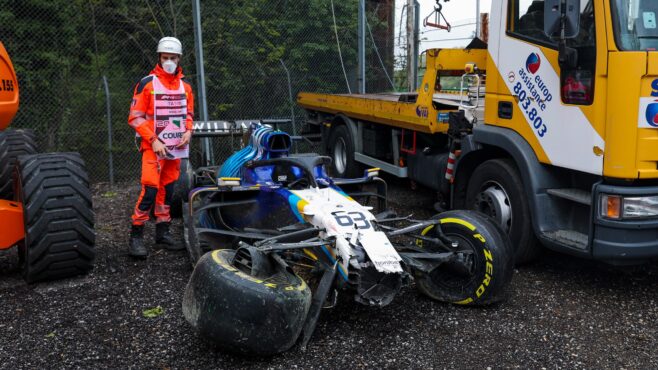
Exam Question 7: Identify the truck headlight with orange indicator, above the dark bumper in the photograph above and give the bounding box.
[600,194,658,220]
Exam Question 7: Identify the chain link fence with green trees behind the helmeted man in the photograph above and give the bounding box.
[0,0,395,182]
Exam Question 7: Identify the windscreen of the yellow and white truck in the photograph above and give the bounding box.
[611,0,658,51]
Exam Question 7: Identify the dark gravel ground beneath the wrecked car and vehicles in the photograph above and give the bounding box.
[0,178,658,369]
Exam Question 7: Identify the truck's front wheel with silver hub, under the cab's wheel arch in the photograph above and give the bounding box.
[466,159,542,265]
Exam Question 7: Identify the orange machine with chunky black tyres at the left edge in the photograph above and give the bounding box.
[0,42,96,282]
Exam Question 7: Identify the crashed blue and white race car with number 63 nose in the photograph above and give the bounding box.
[183,124,513,355]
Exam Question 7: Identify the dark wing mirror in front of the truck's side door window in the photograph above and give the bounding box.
[544,0,580,40]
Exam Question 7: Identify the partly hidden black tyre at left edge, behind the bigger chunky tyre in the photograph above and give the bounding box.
[0,130,37,199]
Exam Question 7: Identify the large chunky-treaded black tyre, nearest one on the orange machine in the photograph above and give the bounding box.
[15,153,96,283]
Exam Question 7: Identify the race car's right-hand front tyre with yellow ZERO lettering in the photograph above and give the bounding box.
[414,211,513,306]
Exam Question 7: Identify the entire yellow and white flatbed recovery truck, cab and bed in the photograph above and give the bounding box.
[297,0,658,264]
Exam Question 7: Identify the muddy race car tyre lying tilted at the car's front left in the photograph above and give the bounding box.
[183,249,311,355]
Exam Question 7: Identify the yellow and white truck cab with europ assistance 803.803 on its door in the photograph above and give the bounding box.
[468,0,658,263]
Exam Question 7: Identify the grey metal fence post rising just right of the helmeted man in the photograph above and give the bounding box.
[192,0,214,166]
